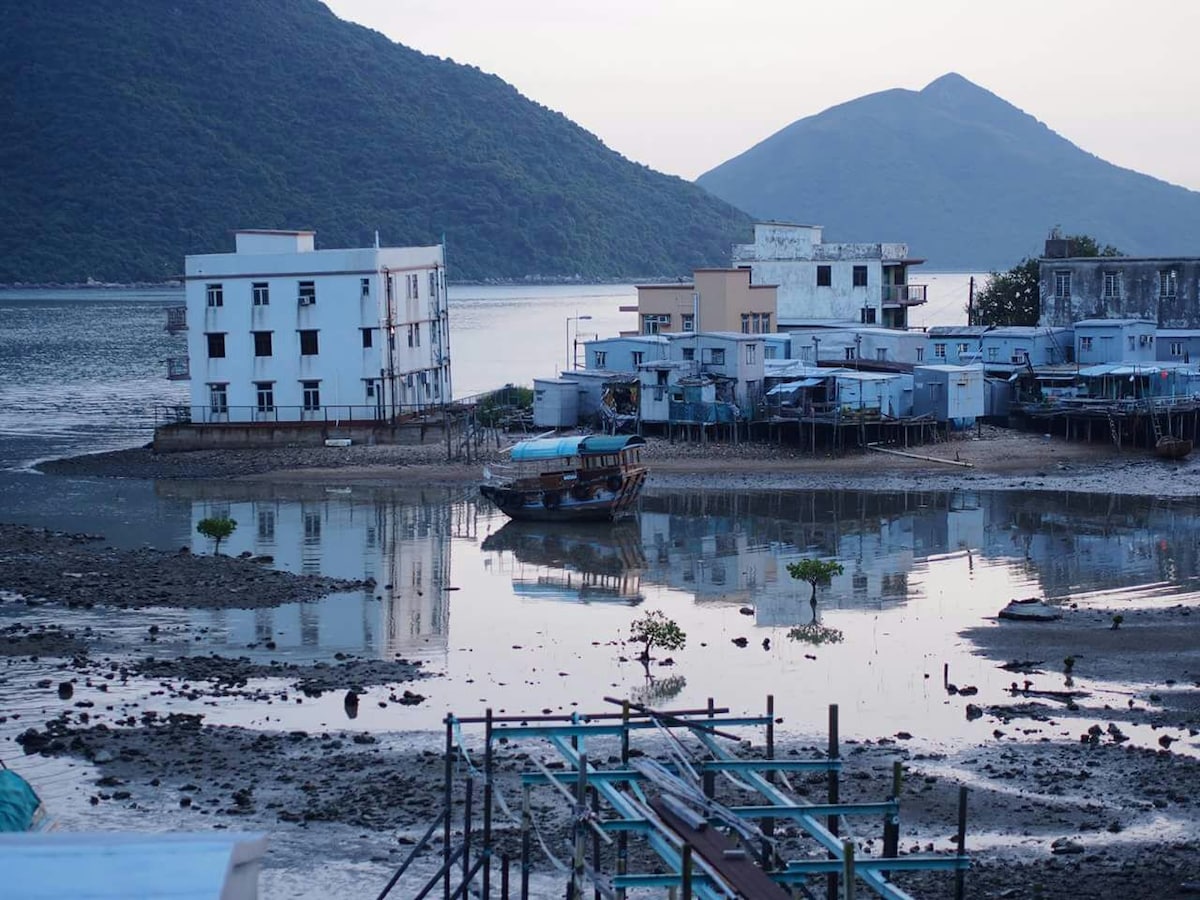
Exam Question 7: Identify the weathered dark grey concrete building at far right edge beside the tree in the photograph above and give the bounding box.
[1038,239,1200,329]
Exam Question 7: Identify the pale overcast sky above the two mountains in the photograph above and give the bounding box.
[325,0,1200,190]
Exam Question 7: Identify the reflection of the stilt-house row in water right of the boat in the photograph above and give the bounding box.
[638,491,1200,626]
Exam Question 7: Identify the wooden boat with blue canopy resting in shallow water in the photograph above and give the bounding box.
[479,434,647,522]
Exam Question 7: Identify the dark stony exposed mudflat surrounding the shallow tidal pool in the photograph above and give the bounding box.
[9,428,1200,898]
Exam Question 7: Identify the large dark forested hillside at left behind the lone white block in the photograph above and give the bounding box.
[0,0,750,283]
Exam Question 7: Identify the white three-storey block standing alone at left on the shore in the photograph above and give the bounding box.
[185,230,451,424]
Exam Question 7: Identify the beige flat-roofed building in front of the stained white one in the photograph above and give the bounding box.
[637,269,778,335]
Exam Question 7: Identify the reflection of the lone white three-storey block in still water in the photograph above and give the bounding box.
[161,482,461,658]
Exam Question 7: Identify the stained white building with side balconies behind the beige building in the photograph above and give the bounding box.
[733,222,925,330]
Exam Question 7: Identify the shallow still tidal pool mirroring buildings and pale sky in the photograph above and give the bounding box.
[110,482,1200,737]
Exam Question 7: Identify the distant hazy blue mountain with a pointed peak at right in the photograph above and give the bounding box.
[697,74,1200,270]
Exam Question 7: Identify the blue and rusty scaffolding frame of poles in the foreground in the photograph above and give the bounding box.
[379,696,970,900]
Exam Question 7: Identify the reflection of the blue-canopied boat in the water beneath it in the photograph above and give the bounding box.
[480,521,646,606]
